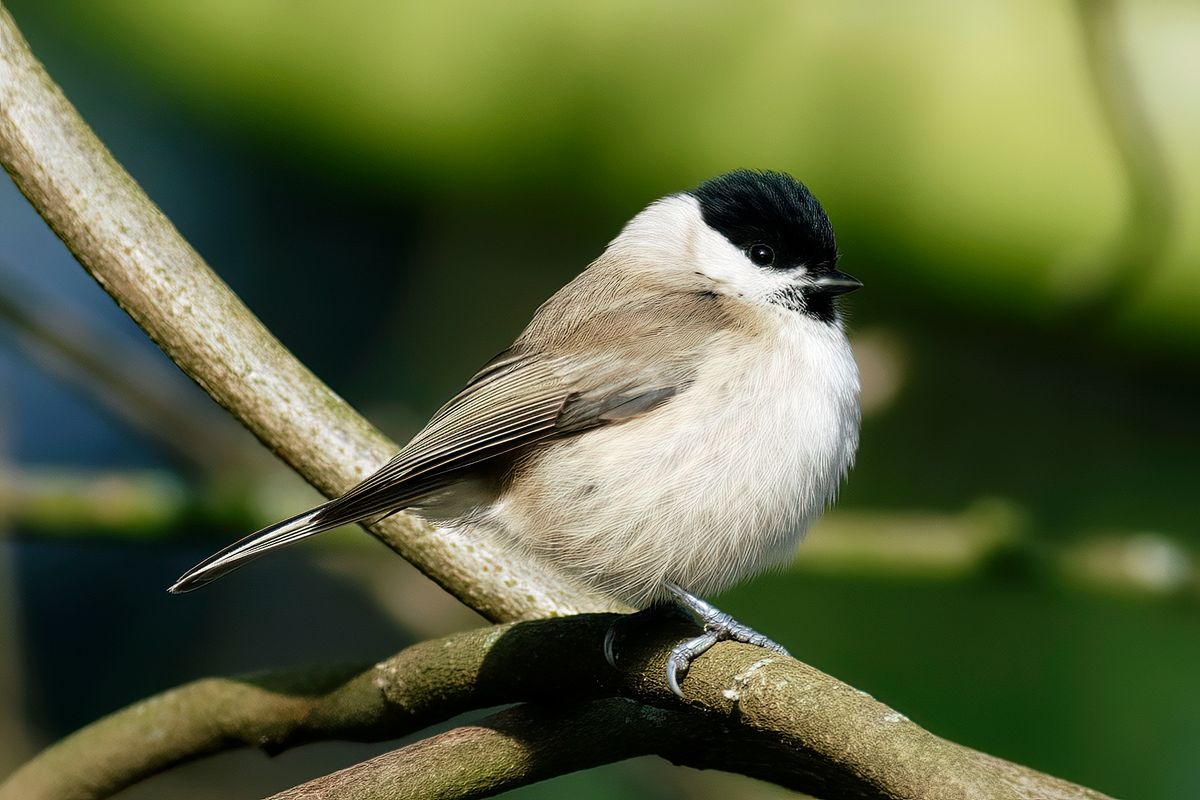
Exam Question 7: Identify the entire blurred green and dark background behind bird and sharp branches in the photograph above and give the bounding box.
[0,0,1200,800]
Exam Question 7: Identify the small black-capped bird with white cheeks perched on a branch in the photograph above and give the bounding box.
[170,170,863,697]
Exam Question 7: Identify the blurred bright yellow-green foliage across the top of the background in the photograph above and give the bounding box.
[21,0,1200,347]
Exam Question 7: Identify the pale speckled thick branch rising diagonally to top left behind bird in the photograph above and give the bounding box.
[0,7,613,620]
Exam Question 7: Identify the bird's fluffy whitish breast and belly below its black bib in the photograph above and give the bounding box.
[487,311,859,604]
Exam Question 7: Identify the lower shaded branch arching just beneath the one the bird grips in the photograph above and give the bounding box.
[268,699,1104,800]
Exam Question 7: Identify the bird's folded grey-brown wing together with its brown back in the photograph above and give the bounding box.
[314,275,737,525]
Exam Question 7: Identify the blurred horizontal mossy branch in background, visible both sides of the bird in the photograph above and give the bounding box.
[0,467,1200,599]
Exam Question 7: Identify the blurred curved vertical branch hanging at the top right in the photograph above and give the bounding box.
[1075,0,1176,319]
